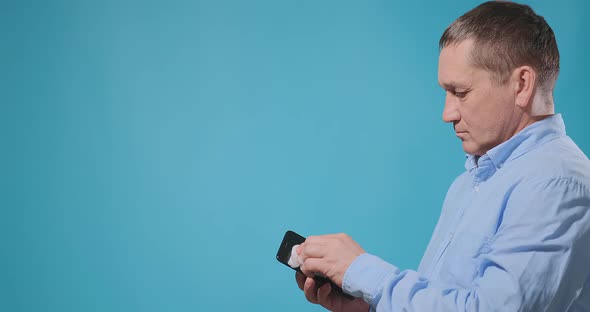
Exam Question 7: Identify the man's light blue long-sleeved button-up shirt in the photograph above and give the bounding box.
[343,115,590,312]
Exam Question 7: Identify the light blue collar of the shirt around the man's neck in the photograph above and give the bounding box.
[465,114,565,181]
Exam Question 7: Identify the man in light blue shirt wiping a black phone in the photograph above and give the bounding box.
[296,2,590,311]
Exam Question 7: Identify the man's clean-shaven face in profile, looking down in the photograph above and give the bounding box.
[438,40,522,156]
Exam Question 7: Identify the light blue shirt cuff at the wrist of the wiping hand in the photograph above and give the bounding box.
[342,253,399,305]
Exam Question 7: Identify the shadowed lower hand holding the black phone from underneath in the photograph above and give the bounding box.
[295,272,369,312]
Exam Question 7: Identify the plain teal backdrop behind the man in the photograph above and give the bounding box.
[0,0,590,312]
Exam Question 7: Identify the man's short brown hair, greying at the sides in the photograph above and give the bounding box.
[439,1,559,92]
